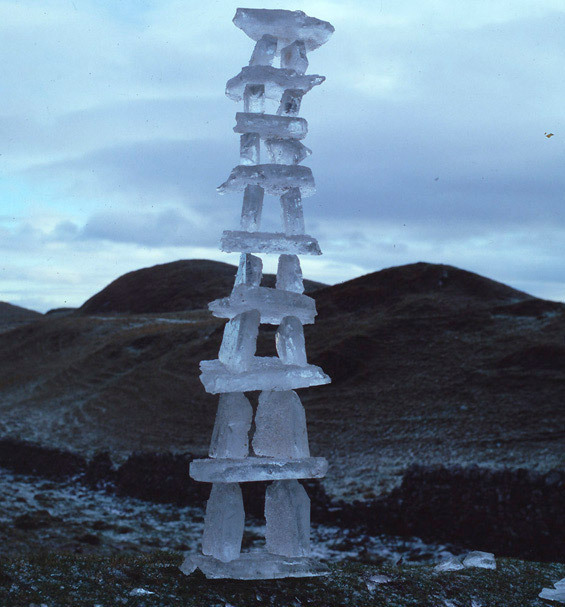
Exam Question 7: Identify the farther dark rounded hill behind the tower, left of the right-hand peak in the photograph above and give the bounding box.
[79,259,325,314]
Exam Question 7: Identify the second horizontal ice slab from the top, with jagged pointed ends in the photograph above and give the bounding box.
[226,65,325,101]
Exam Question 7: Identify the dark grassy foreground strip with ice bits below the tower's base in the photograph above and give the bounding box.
[0,552,565,607]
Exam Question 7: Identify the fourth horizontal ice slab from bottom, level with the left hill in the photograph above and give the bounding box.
[208,285,316,325]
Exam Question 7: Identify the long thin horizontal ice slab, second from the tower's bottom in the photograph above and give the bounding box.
[190,457,328,483]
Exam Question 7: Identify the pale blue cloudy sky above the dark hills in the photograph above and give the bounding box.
[0,0,565,311]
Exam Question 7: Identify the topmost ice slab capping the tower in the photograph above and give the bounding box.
[233,8,335,51]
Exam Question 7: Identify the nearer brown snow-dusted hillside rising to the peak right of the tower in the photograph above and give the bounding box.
[0,263,565,499]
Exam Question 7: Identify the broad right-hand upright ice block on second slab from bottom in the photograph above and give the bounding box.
[253,390,310,459]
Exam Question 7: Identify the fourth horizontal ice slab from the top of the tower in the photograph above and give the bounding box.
[218,164,316,198]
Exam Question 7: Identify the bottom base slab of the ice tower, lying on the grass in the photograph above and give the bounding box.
[180,550,329,580]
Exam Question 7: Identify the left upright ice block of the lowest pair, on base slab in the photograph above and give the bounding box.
[202,483,245,563]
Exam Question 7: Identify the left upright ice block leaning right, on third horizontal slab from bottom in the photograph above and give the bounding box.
[218,310,261,372]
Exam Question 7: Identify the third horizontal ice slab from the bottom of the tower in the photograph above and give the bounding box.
[200,356,331,394]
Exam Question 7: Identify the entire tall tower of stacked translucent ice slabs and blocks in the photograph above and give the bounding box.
[182,8,334,579]
